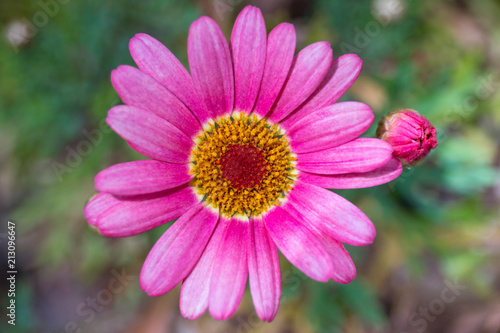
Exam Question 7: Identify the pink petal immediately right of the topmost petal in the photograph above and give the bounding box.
[254,23,297,117]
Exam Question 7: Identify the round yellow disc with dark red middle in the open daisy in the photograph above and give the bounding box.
[190,112,296,217]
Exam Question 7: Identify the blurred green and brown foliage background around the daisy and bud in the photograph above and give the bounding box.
[0,0,500,333]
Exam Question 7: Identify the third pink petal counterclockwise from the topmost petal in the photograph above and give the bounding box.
[111,66,201,137]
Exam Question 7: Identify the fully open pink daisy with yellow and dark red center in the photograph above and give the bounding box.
[85,6,401,321]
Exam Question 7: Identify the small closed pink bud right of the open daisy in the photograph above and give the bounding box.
[377,109,437,168]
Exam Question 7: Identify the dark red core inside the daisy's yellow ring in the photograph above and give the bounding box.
[218,144,267,190]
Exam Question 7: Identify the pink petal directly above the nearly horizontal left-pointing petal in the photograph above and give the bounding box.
[106,105,194,164]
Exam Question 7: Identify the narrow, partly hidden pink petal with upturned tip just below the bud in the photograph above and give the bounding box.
[299,157,403,189]
